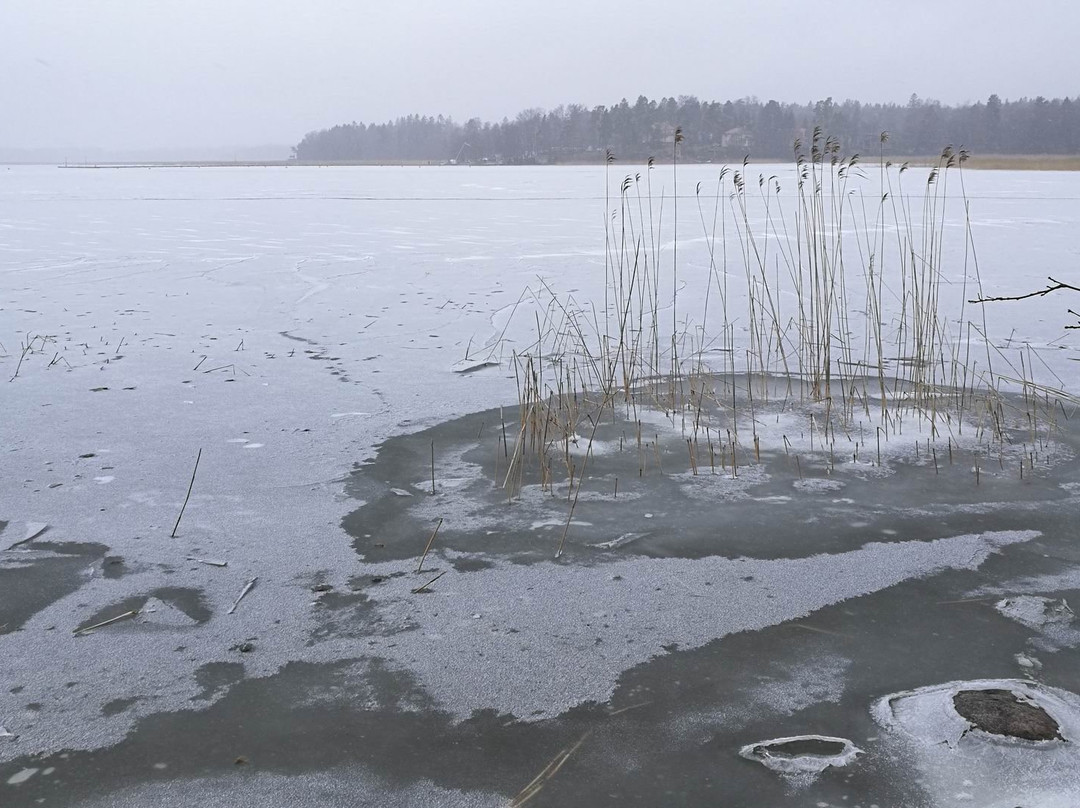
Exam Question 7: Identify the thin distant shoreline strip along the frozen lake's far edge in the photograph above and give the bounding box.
[8,154,1080,171]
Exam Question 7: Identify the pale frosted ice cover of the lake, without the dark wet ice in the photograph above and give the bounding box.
[0,166,1080,808]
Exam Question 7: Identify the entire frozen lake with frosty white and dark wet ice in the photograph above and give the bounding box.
[0,160,1080,808]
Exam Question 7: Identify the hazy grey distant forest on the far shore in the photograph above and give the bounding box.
[293,95,1080,164]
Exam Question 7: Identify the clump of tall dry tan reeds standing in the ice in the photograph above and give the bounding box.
[486,130,1077,552]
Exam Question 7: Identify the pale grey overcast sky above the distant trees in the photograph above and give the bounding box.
[0,0,1080,149]
